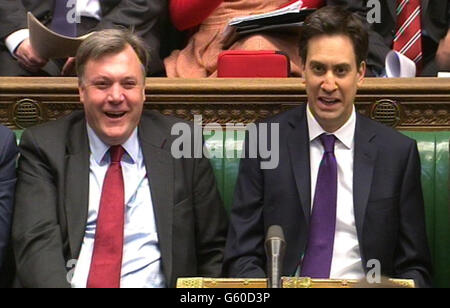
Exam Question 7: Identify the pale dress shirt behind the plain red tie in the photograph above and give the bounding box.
[71,125,166,288]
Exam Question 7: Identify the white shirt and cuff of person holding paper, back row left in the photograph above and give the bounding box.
[5,0,102,56]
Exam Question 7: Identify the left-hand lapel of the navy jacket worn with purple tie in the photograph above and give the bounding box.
[288,104,311,228]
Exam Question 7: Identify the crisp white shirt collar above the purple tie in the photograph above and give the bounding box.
[306,104,356,149]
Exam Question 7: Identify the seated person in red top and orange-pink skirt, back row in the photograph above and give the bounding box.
[164,0,324,78]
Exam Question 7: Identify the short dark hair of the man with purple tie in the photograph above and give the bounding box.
[300,6,369,67]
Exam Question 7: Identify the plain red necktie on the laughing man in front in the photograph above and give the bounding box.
[87,145,125,288]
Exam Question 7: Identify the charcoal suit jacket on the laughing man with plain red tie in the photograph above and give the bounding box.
[12,112,228,287]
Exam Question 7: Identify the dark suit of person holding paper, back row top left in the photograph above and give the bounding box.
[0,0,167,74]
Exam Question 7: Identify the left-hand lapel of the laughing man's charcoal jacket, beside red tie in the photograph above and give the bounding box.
[64,120,89,259]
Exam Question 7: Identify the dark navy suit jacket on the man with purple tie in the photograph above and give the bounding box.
[224,106,430,286]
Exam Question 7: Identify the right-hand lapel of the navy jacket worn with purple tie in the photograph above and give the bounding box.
[353,113,377,249]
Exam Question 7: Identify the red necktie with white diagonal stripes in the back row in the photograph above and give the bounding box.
[393,0,422,72]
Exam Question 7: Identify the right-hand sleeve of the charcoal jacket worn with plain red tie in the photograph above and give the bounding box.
[193,149,228,277]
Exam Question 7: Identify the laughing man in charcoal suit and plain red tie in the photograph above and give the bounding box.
[13,30,227,287]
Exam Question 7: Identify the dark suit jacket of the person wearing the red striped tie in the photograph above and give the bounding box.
[366,0,450,76]
